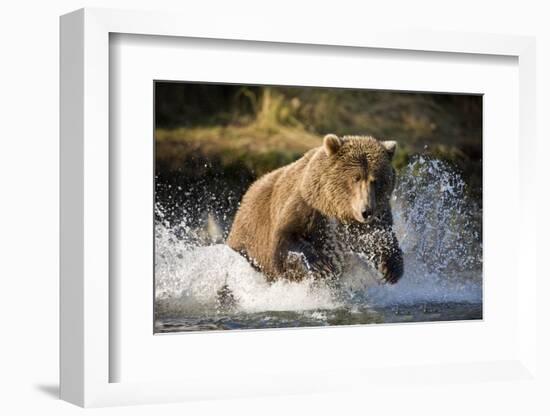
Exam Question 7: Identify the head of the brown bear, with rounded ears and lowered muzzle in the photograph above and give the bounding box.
[300,134,396,223]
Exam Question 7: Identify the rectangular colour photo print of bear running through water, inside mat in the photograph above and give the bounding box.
[154,81,483,333]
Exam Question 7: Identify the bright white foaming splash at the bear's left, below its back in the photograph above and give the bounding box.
[155,237,339,315]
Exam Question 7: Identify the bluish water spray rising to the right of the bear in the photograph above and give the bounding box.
[347,156,482,305]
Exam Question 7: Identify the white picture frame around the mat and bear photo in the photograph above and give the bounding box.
[60,9,537,407]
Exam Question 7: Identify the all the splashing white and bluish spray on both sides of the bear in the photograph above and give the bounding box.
[155,157,482,322]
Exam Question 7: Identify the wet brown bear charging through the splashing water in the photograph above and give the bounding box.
[227,134,403,283]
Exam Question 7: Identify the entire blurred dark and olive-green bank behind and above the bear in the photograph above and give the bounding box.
[155,82,482,210]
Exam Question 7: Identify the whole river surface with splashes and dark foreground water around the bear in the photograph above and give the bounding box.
[155,157,482,332]
